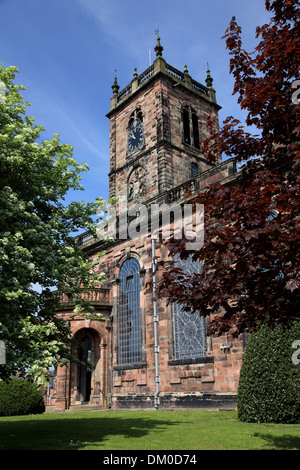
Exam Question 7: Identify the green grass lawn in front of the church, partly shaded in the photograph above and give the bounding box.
[0,410,300,451]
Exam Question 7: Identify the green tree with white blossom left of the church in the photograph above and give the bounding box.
[0,67,103,379]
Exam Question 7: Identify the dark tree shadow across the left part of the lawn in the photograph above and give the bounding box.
[0,415,177,450]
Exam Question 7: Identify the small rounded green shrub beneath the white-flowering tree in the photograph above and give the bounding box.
[0,379,45,416]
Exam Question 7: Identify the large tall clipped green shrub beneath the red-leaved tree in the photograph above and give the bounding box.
[237,321,300,423]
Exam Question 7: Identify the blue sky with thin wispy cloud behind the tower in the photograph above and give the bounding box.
[0,0,269,206]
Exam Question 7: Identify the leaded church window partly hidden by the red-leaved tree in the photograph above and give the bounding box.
[173,256,206,359]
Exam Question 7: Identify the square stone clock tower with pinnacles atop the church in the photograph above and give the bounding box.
[107,36,220,207]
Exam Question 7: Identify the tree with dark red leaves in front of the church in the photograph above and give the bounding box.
[157,0,300,336]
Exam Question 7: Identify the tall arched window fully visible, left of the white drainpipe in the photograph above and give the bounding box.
[118,258,141,364]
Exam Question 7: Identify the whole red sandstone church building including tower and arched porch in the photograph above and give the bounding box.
[51,37,245,410]
